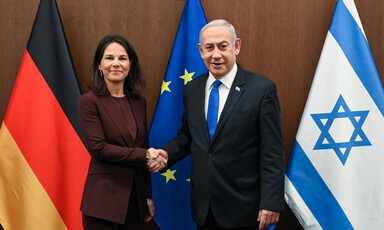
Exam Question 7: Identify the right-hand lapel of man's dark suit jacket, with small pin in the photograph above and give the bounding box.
[212,65,245,142]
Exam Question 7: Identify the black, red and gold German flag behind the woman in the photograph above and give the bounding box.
[0,0,89,230]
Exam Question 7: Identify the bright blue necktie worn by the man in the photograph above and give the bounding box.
[207,80,221,140]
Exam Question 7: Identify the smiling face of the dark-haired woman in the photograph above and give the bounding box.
[99,42,130,85]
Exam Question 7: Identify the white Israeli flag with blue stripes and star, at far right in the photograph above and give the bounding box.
[285,0,384,230]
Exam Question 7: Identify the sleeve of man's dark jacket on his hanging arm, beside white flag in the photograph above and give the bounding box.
[260,84,285,211]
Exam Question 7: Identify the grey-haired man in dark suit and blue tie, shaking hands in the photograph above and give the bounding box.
[148,20,285,230]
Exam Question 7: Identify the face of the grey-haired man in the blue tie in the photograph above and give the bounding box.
[198,26,241,79]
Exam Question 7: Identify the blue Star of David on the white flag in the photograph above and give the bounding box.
[311,95,371,165]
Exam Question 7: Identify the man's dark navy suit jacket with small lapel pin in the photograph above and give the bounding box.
[164,65,285,228]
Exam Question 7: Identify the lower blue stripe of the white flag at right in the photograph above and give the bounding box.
[286,141,353,230]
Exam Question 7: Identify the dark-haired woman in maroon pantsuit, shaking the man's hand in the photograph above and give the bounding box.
[79,35,154,230]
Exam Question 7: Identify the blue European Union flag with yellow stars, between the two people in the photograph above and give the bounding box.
[149,0,207,230]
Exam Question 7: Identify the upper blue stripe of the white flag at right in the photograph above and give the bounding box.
[329,1,384,116]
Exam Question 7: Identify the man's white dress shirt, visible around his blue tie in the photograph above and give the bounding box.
[204,63,237,122]
